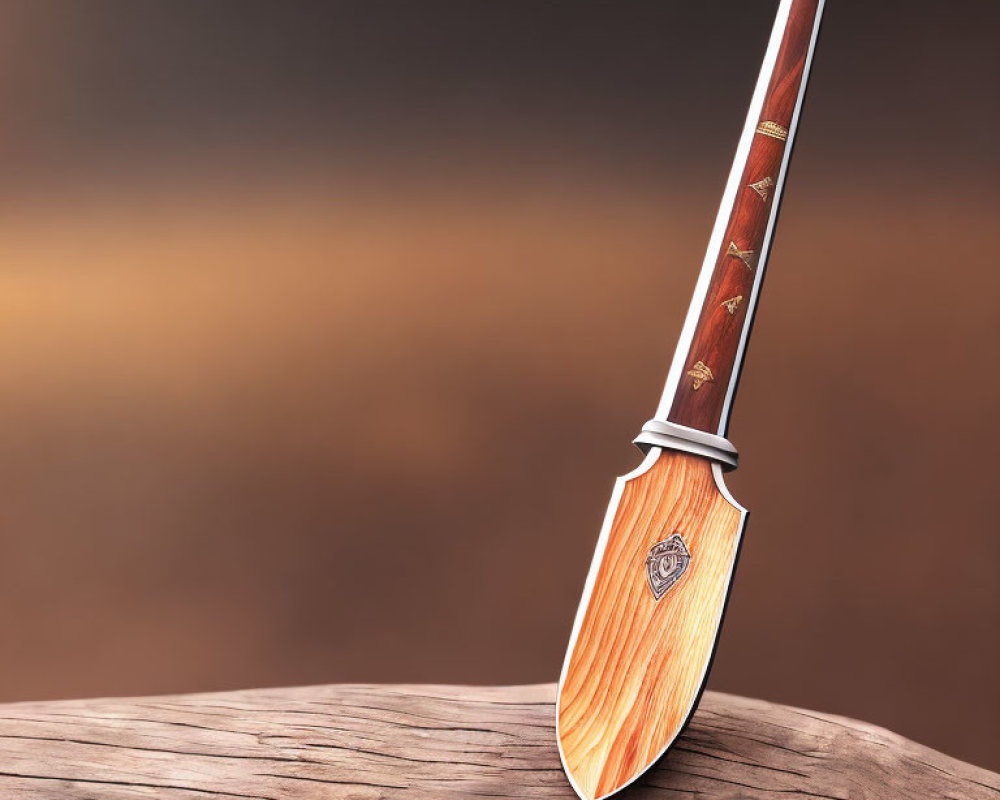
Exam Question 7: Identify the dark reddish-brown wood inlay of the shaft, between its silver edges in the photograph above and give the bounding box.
[668,0,819,433]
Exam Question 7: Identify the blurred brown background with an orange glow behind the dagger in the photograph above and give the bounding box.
[0,0,1000,769]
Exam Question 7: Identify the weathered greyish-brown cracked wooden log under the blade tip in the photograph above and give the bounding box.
[0,685,1000,800]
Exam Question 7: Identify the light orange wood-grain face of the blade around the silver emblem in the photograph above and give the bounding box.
[558,449,745,800]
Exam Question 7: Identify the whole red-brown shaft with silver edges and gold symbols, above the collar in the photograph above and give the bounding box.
[657,0,823,435]
